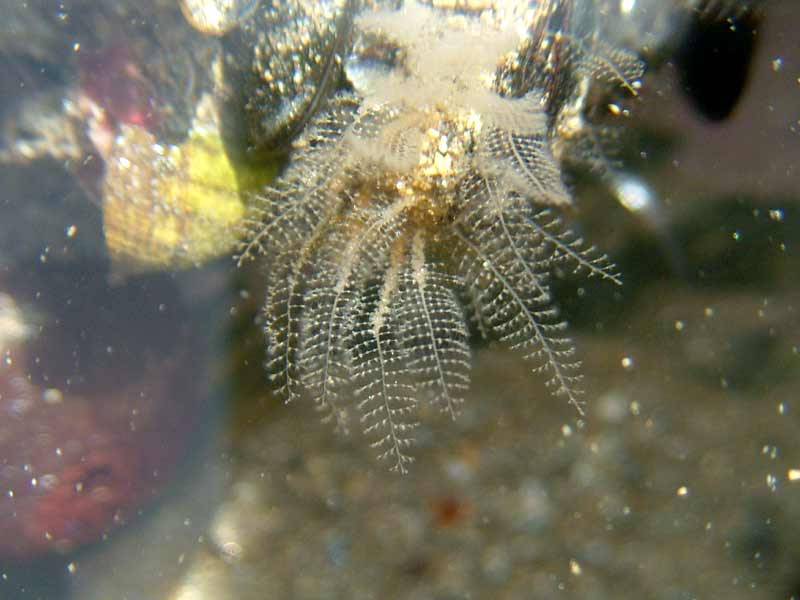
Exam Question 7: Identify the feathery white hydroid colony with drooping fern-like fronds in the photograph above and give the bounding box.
[242,2,640,472]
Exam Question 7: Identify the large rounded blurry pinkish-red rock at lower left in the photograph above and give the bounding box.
[0,270,207,560]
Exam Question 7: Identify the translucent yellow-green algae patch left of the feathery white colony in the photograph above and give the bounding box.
[103,126,272,273]
